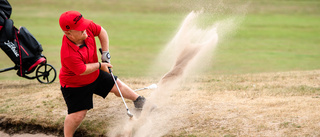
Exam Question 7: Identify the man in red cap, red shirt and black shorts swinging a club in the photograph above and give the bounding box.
[59,11,145,137]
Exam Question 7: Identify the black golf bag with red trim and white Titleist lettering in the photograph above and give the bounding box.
[0,19,46,76]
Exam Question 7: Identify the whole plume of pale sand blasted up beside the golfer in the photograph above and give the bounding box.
[108,3,246,137]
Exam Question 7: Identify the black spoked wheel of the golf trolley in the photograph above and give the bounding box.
[36,64,57,84]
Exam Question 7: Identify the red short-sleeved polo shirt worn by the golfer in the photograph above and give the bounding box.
[59,22,101,87]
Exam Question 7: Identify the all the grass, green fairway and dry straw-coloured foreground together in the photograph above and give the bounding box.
[0,0,320,136]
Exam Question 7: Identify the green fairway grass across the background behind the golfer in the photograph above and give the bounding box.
[0,0,320,79]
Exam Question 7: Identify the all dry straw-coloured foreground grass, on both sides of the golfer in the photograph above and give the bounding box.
[0,70,320,136]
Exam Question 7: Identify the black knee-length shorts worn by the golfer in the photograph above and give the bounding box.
[61,70,117,114]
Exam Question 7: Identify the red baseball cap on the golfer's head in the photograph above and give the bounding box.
[59,11,92,31]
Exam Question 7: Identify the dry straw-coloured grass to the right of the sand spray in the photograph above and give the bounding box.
[171,71,320,136]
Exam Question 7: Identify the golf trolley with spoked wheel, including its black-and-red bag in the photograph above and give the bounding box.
[0,0,57,84]
